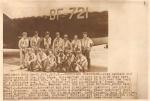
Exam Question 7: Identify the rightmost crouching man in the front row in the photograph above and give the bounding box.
[74,51,88,72]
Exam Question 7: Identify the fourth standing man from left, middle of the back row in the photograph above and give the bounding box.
[52,32,63,55]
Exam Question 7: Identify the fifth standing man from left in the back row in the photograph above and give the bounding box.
[63,34,72,54]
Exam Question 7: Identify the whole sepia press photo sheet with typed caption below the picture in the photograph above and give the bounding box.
[3,0,147,100]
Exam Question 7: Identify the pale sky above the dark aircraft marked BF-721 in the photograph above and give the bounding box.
[2,0,108,18]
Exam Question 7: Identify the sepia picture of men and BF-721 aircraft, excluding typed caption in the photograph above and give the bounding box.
[3,2,108,73]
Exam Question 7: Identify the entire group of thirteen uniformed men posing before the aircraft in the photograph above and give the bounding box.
[18,31,93,72]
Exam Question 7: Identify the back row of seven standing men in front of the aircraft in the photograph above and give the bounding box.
[18,31,93,71]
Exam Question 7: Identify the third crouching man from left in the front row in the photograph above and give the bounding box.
[44,50,57,72]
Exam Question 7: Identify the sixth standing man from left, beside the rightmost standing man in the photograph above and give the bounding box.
[72,35,81,55]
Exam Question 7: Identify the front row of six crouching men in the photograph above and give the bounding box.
[23,48,88,72]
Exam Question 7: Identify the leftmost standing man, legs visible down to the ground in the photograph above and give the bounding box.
[18,32,29,69]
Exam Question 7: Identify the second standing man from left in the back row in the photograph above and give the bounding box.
[30,31,40,53]
